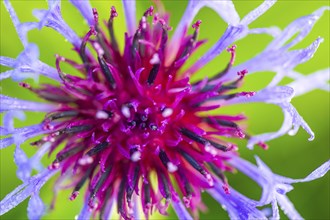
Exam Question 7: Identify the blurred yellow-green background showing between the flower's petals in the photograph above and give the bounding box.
[0,0,330,219]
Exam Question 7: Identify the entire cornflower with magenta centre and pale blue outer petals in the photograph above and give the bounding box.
[0,0,330,219]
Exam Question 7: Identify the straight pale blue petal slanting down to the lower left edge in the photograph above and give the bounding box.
[0,169,58,215]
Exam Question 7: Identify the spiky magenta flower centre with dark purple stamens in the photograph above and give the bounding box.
[21,7,254,218]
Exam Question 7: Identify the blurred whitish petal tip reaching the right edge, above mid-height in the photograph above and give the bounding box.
[288,68,330,97]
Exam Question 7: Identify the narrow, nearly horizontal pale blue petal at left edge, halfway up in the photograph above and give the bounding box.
[0,95,56,112]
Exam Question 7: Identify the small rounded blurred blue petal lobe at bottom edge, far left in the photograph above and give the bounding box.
[27,192,46,220]
